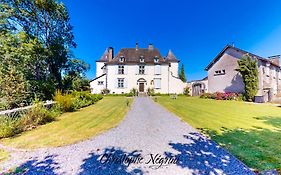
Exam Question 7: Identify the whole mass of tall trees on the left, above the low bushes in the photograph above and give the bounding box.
[0,0,89,106]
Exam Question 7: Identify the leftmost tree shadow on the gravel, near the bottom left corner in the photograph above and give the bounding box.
[10,155,60,175]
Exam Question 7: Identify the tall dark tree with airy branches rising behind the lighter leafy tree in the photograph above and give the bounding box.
[0,0,76,88]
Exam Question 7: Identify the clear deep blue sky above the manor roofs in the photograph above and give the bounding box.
[62,0,281,81]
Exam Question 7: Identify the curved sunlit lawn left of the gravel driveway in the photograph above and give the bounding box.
[1,97,133,148]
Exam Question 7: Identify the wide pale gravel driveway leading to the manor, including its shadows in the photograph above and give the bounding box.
[0,97,252,175]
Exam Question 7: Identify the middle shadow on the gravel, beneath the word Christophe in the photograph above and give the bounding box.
[79,147,143,175]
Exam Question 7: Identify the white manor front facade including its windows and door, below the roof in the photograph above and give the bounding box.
[90,45,187,94]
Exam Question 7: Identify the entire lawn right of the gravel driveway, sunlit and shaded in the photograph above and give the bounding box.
[157,97,281,170]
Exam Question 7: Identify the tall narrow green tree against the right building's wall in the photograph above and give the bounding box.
[238,54,258,101]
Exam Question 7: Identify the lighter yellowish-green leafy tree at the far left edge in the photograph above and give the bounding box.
[0,32,33,108]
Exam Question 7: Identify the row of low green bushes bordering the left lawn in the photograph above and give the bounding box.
[0,91,100,139]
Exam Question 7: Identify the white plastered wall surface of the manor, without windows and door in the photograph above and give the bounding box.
[90,62,186,94]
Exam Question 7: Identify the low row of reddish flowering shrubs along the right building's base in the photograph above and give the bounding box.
[200,92,239,100]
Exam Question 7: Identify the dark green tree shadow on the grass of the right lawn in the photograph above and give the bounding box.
[198,117,281,171]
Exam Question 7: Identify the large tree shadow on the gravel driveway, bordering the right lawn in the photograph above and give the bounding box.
[165,133,253,175]
